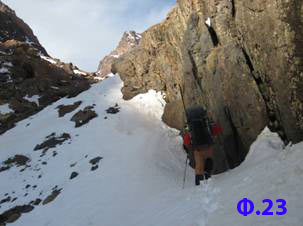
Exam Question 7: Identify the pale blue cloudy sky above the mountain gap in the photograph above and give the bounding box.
[2,0,176,71]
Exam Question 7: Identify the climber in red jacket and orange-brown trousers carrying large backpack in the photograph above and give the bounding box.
[183,107,222,185]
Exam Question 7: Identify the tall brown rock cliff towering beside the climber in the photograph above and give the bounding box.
[113,0,303,171]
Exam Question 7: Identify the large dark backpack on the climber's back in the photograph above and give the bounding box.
[187,107,213,146]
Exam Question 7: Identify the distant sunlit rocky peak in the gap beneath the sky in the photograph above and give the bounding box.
[97,31,141,77]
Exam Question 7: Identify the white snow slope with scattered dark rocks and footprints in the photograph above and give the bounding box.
[0,77,303,226]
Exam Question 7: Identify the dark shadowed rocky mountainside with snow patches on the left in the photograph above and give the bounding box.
[0,1,93,134]
